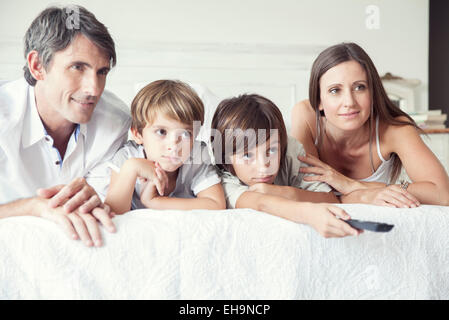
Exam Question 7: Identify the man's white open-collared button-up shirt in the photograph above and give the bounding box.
[0,78,131,204]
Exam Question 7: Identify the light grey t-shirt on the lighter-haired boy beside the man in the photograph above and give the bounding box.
[109,141,221,209]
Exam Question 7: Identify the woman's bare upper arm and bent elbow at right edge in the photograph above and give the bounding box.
[385,125,449,206]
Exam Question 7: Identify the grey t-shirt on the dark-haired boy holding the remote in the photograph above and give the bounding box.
[221,137,332,209]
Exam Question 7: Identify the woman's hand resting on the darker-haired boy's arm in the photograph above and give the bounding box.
[298,154,363,194]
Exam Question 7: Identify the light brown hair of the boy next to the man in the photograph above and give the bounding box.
[131,80,204,134]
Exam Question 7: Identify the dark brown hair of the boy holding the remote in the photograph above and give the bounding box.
[211,94,288,174]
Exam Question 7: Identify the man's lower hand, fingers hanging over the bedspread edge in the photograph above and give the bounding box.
[35,197,115,247]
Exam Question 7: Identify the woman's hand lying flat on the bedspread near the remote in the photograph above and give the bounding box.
[342,184,420,208]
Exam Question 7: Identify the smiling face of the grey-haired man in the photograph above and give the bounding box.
[36,34,110,123]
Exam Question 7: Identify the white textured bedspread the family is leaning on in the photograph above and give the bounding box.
[0,205,449,299]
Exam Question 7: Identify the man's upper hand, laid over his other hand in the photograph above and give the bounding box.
[37,178,104,213]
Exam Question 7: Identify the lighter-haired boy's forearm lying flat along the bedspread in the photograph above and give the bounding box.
[144,183,226,210]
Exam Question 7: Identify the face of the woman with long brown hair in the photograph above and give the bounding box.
[319,60,371,131]
